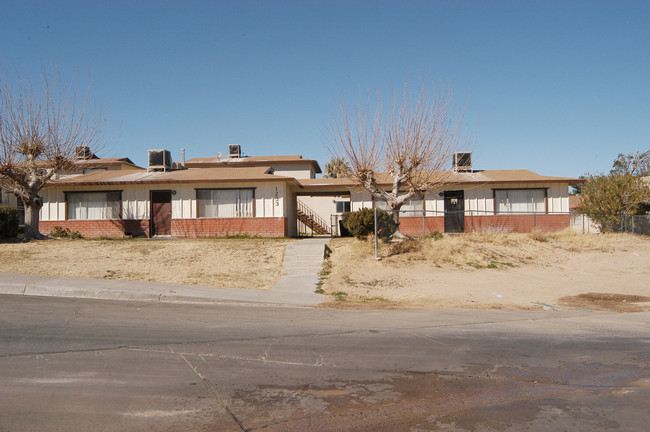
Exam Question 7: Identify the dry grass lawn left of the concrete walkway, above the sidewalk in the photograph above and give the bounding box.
[0,239,293,289]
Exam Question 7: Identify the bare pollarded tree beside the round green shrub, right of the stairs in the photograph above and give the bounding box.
[328,87,462,237]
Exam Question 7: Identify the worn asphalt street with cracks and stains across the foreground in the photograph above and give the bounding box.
[0,295,650,431]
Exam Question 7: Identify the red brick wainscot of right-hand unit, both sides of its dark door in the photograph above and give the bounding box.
[399,214,571,237]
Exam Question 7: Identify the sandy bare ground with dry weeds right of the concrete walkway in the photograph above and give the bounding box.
[322,235,650,312]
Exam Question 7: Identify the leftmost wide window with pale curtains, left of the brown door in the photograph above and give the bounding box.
[65,191,122,220]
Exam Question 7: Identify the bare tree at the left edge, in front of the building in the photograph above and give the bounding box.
[0,72,101,239]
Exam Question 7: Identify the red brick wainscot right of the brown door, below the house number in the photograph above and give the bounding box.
[172,217,288,238]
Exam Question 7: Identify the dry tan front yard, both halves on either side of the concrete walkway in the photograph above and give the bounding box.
[0,232,650,312]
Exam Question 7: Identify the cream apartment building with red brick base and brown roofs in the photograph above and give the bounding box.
[11,145,579,238]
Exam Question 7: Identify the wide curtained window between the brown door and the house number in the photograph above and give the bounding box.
[196,189,255,218]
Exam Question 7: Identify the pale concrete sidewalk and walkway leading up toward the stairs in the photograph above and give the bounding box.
[0,238,329,306]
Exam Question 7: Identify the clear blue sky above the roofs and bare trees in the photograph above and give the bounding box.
[0,0,650,177]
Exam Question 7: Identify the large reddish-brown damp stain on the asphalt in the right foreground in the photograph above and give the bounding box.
[221,356,650,432]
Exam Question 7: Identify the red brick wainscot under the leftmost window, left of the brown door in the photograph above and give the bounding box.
[39,219,149,238]
